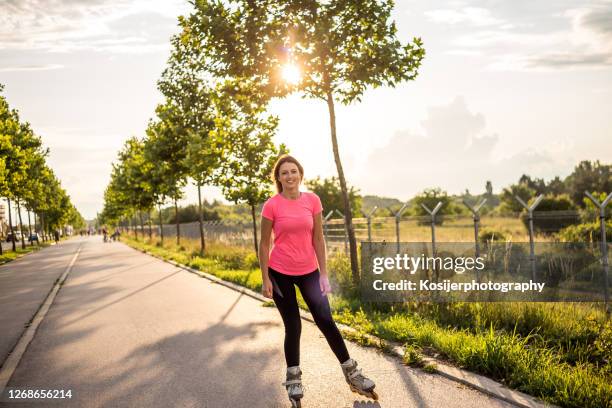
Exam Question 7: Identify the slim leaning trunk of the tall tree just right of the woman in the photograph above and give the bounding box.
[327,90,359,285]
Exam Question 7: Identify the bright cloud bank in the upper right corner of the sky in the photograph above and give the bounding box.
[442,2,612,71]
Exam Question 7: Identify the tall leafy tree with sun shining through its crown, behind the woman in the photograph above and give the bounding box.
[180,0,425,283]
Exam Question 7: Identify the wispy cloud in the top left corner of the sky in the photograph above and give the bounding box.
[0,0,187,53]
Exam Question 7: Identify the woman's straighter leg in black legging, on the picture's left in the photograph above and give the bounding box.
[268,268,302,367]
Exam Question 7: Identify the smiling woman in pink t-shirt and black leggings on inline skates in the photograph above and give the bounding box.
[259,155,378,407]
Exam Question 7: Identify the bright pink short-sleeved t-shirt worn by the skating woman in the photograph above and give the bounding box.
[261,192,323,275]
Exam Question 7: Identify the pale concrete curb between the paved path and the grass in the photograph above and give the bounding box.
[126,244,557,408]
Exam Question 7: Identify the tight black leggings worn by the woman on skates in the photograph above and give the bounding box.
[268,268,349,367]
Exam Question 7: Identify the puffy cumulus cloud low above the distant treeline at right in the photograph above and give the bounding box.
[356,97,574,198]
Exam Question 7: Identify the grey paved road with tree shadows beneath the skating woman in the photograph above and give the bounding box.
[0,237,510,408]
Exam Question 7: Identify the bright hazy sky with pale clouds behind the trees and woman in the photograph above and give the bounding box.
[0,0,612,219]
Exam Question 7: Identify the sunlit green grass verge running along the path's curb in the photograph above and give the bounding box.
[122,233,612,407]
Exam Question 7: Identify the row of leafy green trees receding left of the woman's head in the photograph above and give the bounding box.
[98,51,287,254]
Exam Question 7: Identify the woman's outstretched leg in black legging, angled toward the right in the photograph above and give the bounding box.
[297,270,350,363]
